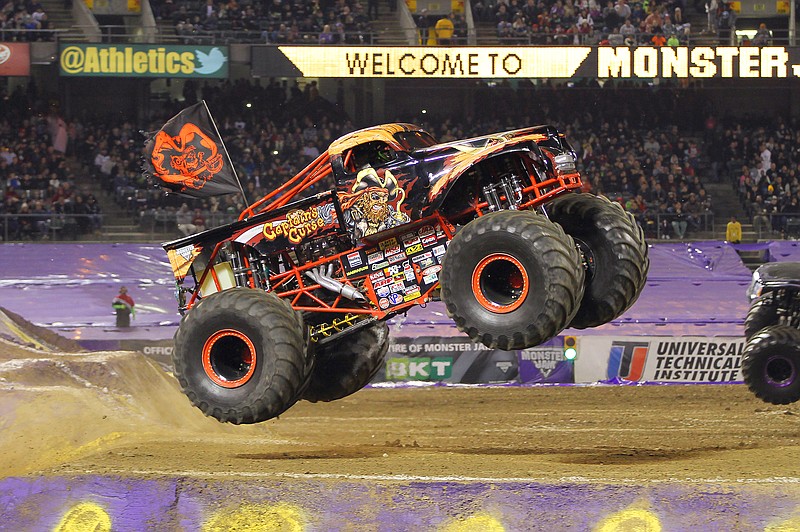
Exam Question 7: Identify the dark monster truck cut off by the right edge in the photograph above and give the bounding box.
[742,262,800,405]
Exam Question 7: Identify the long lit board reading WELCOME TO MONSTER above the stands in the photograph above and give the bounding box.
[252,46,800,79]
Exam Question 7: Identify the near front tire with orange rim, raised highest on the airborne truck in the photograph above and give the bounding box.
[439,211,584,350]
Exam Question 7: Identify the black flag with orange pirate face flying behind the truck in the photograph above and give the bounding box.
[143,101,243,198]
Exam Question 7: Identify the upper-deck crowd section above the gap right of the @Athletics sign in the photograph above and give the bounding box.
[151,0,374,44]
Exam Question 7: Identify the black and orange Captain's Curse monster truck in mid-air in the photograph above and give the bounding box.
[164,123,649,424]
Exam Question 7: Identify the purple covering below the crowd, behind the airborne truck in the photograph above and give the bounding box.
[0,242,764,340]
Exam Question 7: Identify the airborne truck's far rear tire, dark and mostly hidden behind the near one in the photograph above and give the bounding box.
[303,321,389,403]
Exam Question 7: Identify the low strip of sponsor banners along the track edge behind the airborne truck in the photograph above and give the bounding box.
[90,333,745,385]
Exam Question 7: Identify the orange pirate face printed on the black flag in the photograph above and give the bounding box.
[151,124,223,189]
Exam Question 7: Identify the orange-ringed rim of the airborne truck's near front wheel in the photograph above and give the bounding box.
[472,253,530,314]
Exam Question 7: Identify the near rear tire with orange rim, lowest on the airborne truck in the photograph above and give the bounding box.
[172,288,313,425]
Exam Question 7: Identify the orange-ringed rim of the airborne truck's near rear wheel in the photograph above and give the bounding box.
[203,329,256,388]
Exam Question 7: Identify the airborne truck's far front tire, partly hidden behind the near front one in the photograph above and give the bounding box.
[546,194,650,329]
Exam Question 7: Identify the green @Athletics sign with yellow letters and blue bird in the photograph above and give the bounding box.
[58,44,229,78]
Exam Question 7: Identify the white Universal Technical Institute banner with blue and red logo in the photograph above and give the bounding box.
[575,336,745,383]
